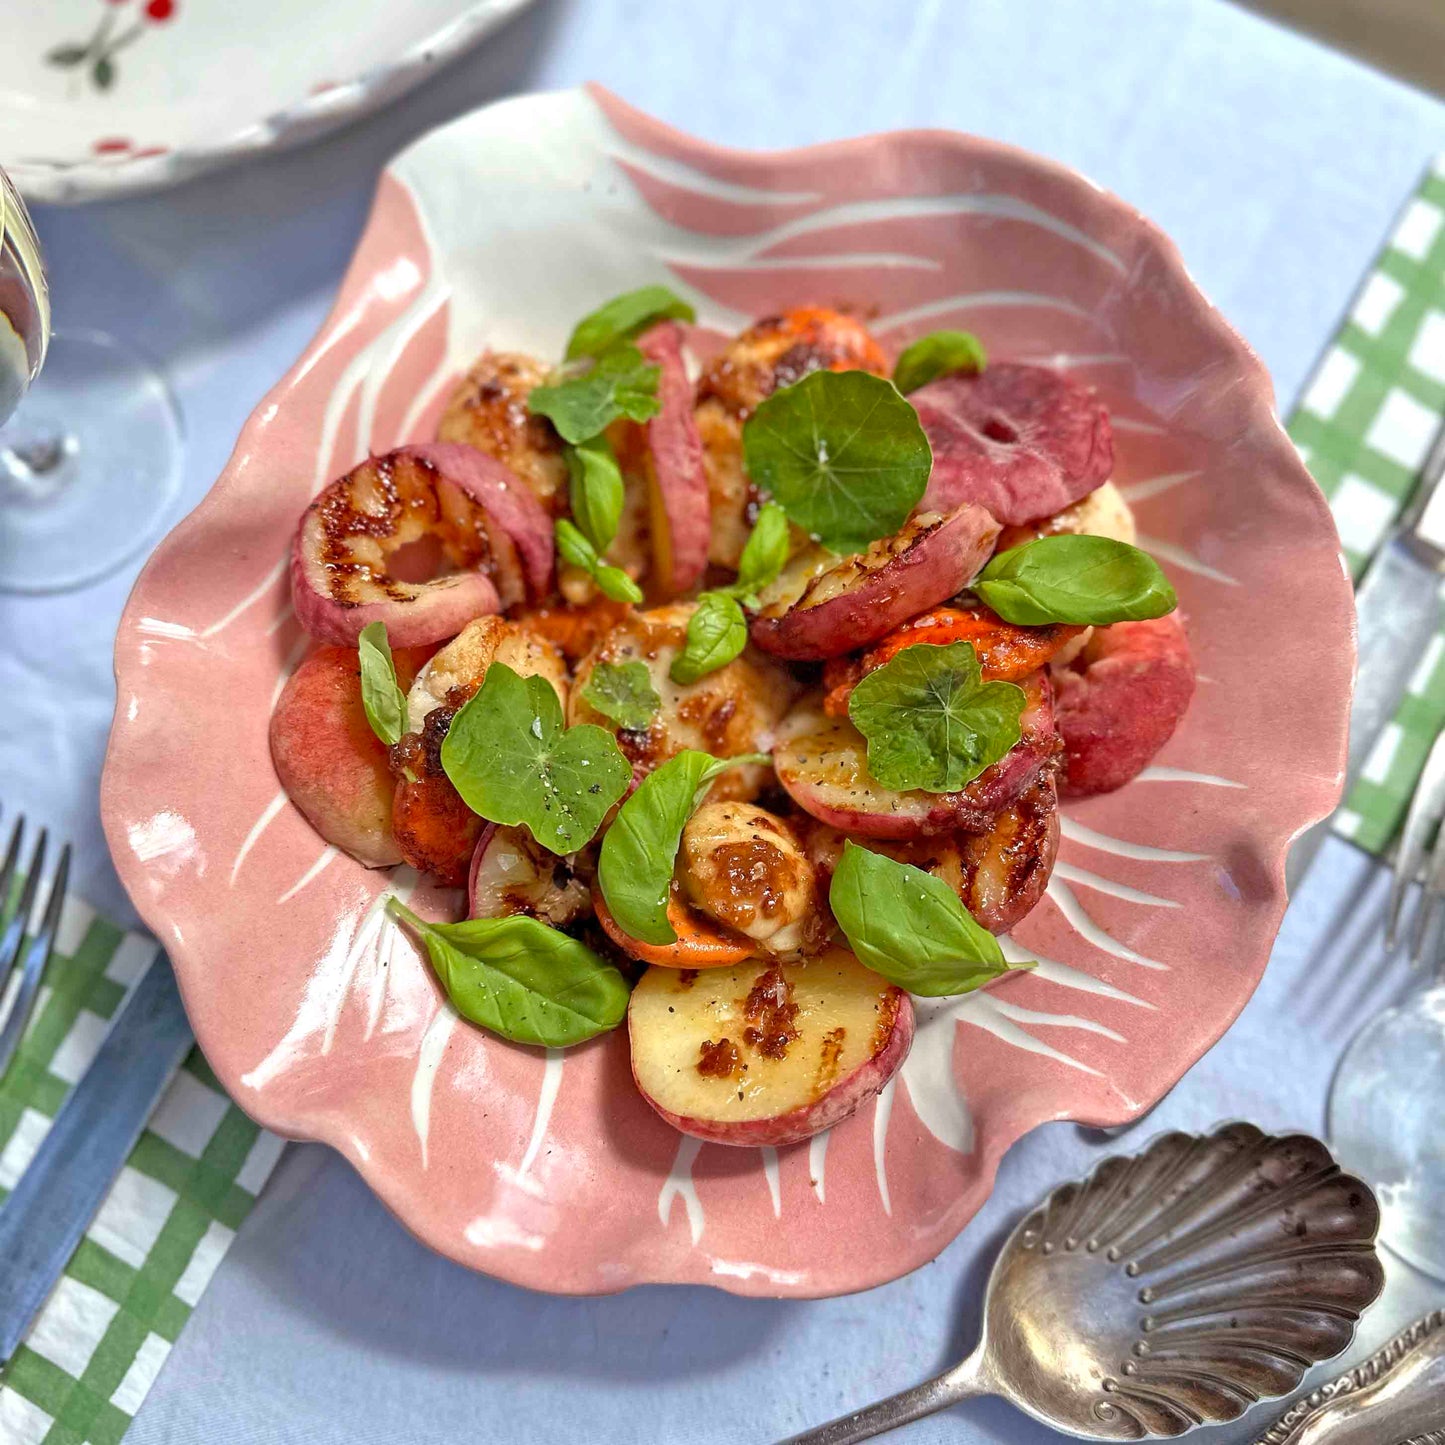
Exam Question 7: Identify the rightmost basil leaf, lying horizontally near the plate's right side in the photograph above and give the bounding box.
[974,533,1179,627]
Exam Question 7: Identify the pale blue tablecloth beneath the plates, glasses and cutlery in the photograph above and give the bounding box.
[11,0,1445,1445]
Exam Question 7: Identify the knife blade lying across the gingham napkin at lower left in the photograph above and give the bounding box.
[0,948,194,1364]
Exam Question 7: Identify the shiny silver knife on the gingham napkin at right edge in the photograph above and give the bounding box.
[1285,426,1445,893]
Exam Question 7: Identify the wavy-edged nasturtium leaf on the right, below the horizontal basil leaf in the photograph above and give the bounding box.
[848,642,1026,793]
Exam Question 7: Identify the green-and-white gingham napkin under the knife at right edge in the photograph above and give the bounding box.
[1289,158,1445,853]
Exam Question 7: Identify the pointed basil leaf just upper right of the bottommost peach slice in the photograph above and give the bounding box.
[828,842,1009,998]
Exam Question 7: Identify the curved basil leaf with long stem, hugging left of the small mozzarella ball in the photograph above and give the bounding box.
[597,747,769,944]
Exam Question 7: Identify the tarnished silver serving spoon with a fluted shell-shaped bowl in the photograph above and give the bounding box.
[786,1124,1384,1445]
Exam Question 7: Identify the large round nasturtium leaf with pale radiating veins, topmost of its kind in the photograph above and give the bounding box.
[743,371,933,553]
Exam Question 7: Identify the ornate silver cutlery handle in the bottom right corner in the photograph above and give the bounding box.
[1254,1309,1445,1445]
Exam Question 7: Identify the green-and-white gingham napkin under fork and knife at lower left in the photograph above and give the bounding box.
[0,897,282,1445]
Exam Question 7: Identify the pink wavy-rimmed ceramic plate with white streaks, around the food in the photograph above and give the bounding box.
[104,90,1353,1295]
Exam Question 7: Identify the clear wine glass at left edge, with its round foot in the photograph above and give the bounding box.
[0,171,181,592]
